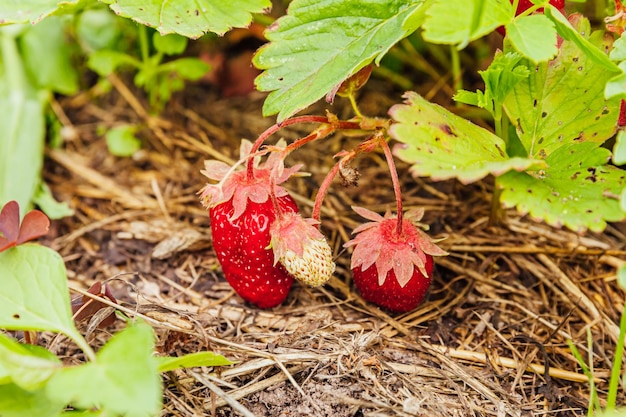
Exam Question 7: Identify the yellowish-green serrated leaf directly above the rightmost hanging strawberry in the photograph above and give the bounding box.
[389,93,542,184]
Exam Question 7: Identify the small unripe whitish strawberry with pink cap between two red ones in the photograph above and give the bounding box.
[270,212,335,287]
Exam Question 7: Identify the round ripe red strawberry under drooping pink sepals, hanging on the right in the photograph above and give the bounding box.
[344,207,446,312]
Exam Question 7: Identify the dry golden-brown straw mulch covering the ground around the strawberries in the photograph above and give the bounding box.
[45,78,626,417]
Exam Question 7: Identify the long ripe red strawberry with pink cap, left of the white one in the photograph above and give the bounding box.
[200,141,299,308]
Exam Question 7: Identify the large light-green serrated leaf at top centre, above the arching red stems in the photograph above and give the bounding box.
[253,0,426,122]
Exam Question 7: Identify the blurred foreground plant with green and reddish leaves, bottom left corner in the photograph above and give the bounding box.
[0,201,231,417]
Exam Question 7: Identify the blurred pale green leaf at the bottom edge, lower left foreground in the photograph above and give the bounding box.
[46,323,162,417]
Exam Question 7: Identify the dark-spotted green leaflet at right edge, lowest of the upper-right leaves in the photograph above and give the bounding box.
[497,142,626,232]
